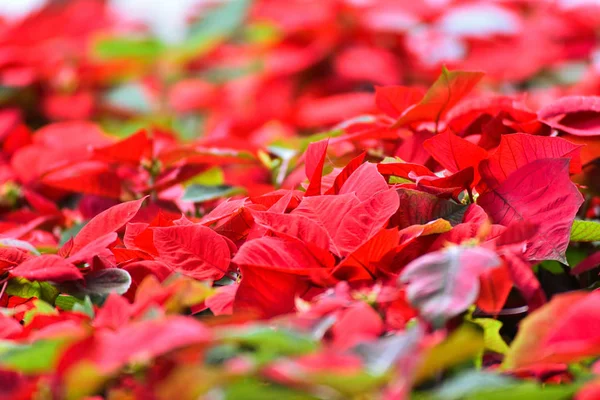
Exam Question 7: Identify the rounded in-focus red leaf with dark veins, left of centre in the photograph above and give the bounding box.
[153,225,230,280]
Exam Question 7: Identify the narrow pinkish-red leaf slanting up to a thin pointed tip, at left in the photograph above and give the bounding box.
[71,197,146,254]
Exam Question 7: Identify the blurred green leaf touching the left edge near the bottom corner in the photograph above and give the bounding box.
[0,338,67,374]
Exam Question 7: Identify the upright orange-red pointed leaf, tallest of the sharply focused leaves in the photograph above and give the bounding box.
[393,67,484,127]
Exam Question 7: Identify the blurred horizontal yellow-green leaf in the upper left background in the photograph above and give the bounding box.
[92,37,165,60]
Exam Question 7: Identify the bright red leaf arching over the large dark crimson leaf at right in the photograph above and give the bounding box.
[480,134,583,188]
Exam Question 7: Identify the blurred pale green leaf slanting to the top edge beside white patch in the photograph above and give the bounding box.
[182,0,251,56]
